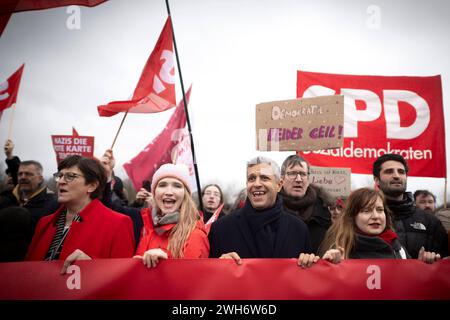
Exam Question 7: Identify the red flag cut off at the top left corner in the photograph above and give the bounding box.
[0,0,107,35]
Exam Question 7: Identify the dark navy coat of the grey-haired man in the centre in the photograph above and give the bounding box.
[209,197,311,258]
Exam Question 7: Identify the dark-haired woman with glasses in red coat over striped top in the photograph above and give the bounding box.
[27,156,134,273]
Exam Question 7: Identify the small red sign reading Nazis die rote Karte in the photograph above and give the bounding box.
[52,128,94,164]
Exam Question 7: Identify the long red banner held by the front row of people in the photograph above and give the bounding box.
[0,259,450,300]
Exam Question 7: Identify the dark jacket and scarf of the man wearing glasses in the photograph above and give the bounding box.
[279,185,331,253]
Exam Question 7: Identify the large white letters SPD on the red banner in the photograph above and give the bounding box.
[303,85,430,140]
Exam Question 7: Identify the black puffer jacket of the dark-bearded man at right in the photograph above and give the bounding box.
[387,192,448,259]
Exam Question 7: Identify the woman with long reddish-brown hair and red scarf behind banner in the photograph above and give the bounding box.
[321,188,441,263]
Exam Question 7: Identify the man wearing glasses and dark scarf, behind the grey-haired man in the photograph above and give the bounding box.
[279,155,331,253]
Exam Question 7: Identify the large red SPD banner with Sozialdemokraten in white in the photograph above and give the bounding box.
[297,71,447,178]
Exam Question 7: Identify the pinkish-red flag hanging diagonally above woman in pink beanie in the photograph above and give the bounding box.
[123,88,191,190]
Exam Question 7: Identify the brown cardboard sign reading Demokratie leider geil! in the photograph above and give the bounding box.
[256,95,344,151]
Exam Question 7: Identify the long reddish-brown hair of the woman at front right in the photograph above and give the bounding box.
[319,188,393,259]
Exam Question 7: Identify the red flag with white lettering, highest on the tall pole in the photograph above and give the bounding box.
[97,17,176,117]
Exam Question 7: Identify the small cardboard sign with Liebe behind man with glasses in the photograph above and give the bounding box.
[309,166,352,197]
